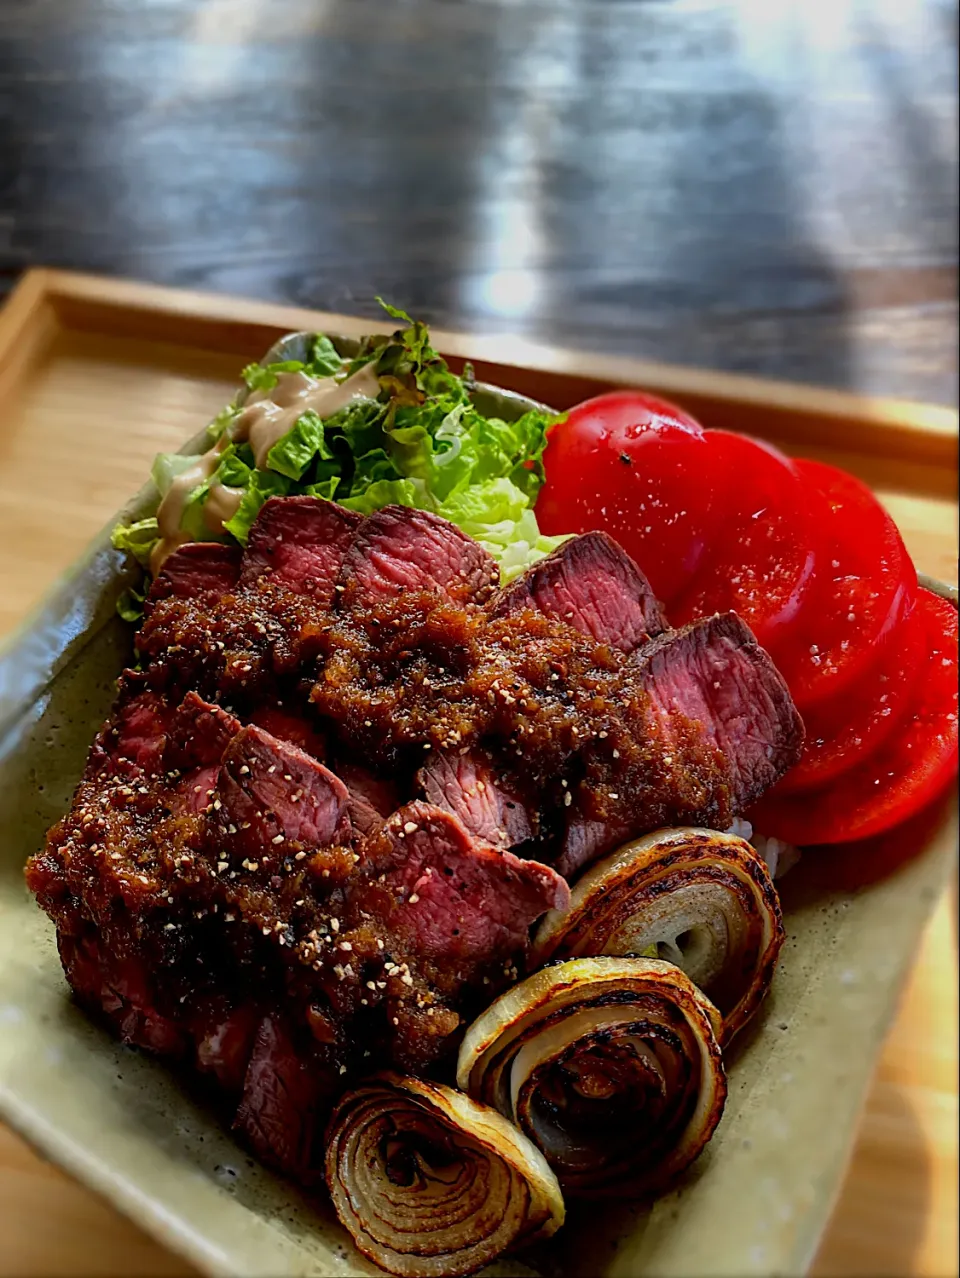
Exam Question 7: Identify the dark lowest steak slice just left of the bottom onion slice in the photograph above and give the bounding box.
[234,1016,325,1180]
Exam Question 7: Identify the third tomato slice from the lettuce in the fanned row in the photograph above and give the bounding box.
[773,461,917,712]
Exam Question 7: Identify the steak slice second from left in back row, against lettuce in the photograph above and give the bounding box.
[240,497,362,607]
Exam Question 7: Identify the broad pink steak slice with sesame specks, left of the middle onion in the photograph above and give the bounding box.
[365,800,570,967]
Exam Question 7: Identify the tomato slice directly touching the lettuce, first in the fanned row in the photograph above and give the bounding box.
[537,391,720,601]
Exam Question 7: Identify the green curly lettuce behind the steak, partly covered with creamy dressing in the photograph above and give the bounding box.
[115,302,575,613]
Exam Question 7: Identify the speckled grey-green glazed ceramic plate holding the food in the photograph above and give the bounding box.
[0,337,956,1278]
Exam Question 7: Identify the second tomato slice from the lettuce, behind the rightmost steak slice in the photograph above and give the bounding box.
[670,431,819,647]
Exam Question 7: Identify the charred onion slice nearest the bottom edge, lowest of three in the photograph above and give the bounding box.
[326,1074,564,1278]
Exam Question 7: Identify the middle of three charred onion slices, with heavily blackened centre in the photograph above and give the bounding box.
[456,957,726,1196]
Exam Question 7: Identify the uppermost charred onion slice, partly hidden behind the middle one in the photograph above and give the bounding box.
[532,829,784,1044]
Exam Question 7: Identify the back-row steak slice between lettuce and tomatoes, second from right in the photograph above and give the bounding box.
[492,533,667,652]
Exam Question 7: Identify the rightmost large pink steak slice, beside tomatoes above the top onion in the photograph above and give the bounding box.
[556,612,804,877]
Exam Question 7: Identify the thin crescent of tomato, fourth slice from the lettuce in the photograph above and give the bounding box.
[772,592,929,796]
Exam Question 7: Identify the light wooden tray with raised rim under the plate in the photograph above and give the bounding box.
[0,271,956,1274]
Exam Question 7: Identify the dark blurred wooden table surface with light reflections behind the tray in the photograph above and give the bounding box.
[0,0,957,401]
